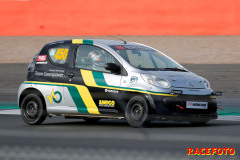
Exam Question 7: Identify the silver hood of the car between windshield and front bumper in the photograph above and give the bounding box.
[142,71,206,89]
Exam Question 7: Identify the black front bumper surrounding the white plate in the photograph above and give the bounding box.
[152,95,218,120]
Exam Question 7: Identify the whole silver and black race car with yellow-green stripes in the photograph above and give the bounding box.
[18,39,219,127]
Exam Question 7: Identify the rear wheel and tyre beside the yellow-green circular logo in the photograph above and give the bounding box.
[21,94,47,125]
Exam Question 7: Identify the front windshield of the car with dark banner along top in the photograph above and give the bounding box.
[110,45,185,71]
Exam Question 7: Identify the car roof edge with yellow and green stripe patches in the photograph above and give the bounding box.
[46,39,139,46]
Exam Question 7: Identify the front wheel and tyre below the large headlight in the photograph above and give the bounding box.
[125,96,150,127]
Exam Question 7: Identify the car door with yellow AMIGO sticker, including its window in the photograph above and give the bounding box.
[66,44,121,114]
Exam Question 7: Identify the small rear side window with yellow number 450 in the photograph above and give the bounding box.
[48,45,69,64]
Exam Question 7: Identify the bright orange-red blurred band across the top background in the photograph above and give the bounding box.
[0,0,240,36]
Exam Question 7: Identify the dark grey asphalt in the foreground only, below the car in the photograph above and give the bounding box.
[0,115,240,160]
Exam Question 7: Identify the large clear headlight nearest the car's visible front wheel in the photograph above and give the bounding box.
[141,74,171,88]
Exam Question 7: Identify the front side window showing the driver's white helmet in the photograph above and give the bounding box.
[75,45,117,72]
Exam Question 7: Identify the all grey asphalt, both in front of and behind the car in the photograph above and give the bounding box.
[0,64,240,160]
